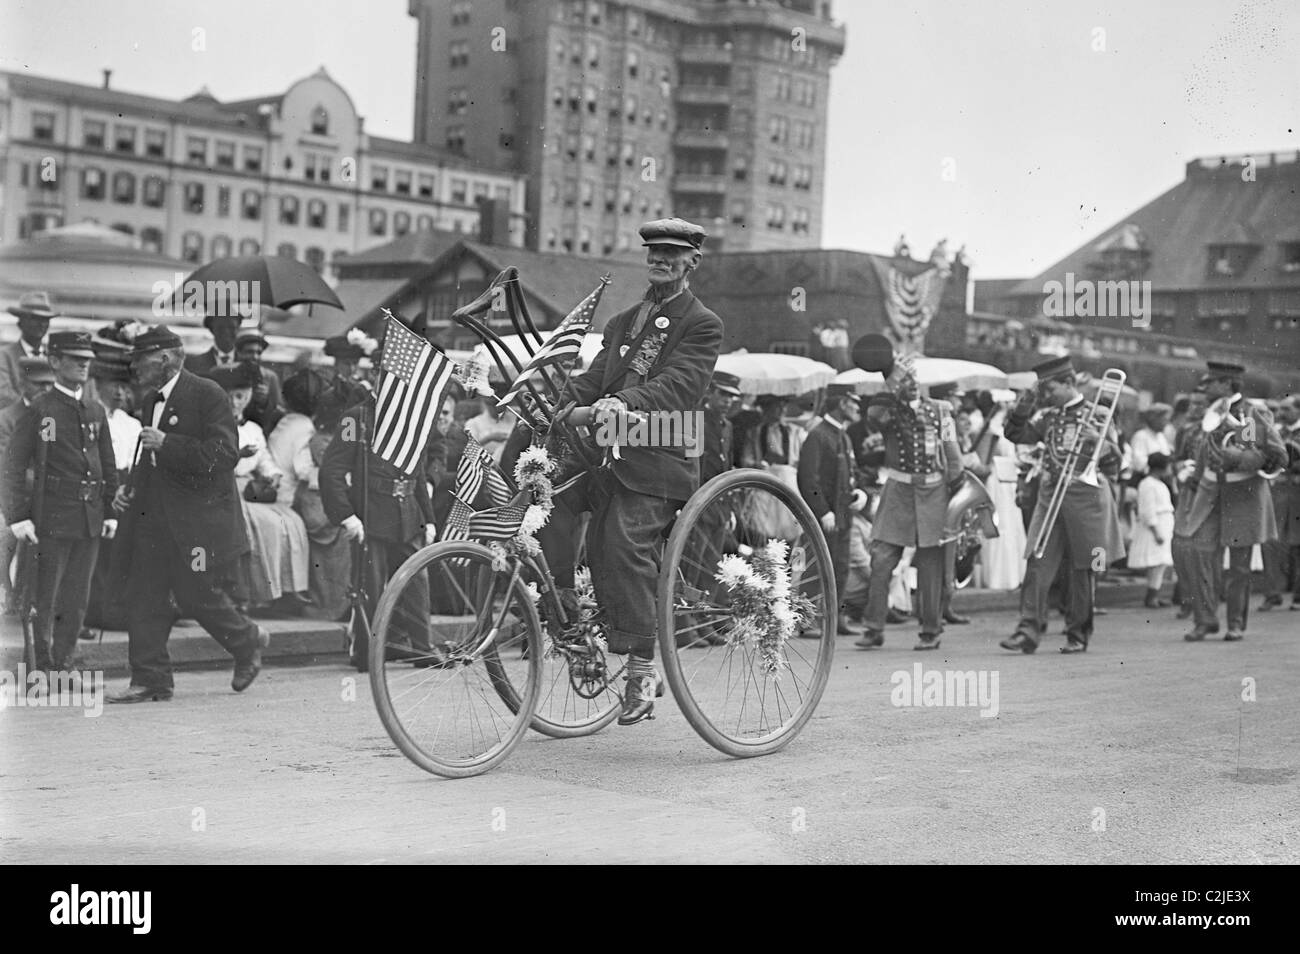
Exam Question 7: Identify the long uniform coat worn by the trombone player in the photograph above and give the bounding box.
[1004,395,1126,569]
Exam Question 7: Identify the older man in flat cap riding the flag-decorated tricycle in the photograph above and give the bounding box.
[556,218,723,725]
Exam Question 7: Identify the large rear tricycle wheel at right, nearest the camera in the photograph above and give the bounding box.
[659,469,839,758]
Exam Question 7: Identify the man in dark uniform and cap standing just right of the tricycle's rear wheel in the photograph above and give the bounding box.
[800,385,867,639]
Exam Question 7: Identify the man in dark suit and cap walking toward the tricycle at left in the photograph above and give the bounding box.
[108,325,270,703]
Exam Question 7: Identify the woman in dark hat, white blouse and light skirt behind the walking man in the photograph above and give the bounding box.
[208,364,308,606]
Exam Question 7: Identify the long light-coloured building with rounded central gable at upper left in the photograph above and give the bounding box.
[0,69,525,270]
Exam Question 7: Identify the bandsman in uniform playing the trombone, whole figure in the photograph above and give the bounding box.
[998,356,1125,654]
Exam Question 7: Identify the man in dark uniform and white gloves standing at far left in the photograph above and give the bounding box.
[4,331,117,669]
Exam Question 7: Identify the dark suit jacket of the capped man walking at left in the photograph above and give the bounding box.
[118,370,248,567]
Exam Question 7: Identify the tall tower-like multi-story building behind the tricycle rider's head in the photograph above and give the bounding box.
[408,0,845,256]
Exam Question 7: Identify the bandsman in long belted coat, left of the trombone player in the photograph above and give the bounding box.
[854,356,962,650]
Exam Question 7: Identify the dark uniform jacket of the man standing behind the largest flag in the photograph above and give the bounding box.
[320,399,433,543]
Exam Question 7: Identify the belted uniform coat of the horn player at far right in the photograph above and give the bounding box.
[1187,395,1287,547]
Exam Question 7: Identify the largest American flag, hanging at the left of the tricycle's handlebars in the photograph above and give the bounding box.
[371,315,456,474]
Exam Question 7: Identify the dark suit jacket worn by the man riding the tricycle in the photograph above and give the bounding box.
[568,289,723,500]
